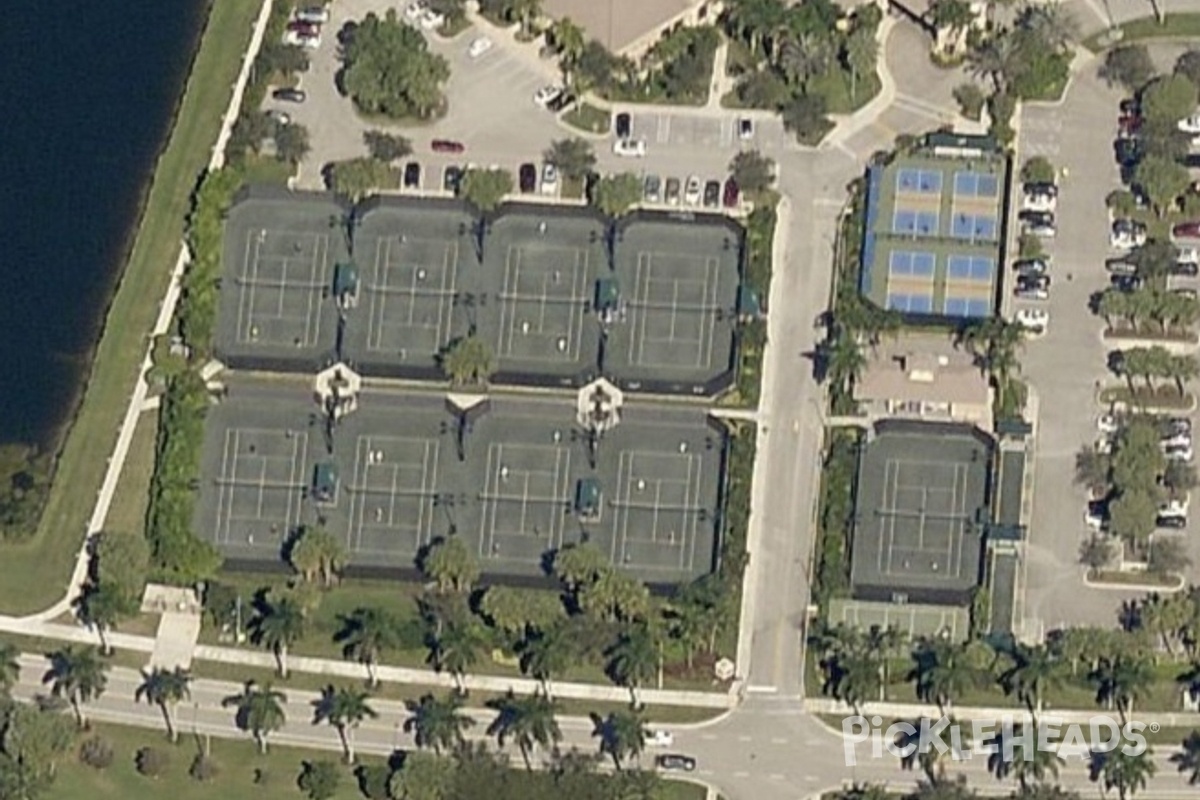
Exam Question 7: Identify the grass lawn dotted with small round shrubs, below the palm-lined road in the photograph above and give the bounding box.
[48,724,369,800]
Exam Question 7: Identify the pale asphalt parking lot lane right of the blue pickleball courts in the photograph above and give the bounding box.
[1014,64,1200,633]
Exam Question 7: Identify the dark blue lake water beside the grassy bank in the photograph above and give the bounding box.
[0,0,208,444]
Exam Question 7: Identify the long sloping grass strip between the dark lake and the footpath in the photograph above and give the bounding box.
[0,0,260,618]
